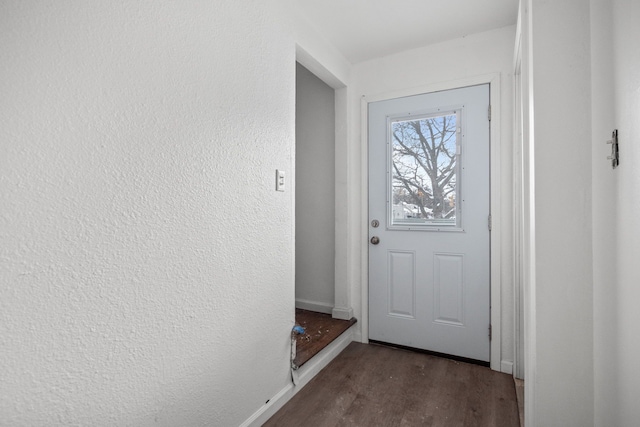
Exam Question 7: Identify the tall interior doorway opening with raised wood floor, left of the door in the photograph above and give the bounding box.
[292,62,356,369]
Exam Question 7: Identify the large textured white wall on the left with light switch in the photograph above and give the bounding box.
[0,0,295,426]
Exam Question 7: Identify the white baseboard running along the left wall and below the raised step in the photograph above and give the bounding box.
[240,326,353,427]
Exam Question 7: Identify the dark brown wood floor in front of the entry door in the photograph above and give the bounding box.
[264,343,520,427]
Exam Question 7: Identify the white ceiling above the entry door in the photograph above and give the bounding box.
[296,0,518,64]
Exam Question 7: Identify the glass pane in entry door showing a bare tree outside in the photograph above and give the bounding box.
[390,112,458,227]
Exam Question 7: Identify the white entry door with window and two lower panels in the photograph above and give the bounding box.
[369,85,490,362]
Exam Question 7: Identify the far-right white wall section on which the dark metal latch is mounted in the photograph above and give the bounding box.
[591,0,640,427]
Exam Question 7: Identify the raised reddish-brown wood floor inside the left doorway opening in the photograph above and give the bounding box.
[293,308,356,367]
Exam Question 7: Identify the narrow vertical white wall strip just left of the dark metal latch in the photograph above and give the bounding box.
[590,0,621,427]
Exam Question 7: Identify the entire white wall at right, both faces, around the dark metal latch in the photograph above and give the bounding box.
[522,0,640,427]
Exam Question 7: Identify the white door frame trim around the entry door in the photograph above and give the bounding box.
[360,73,504,374]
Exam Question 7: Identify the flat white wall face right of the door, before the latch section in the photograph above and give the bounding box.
[523,0,594,426]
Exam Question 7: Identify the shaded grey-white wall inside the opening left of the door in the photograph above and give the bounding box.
[295,64,336,313]
